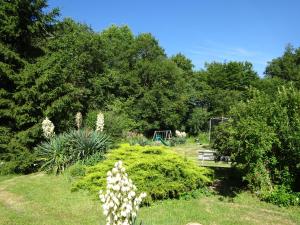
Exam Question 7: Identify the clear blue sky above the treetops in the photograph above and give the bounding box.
[48,0,300,76]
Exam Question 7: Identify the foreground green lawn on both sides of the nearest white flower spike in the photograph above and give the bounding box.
[0,173,300,225]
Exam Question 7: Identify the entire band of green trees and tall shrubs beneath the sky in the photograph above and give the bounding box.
[0,0,300,185]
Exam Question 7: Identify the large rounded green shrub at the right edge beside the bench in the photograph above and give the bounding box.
[214,86,300,205]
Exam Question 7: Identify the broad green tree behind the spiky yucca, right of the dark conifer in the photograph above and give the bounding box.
[10,19,103,166]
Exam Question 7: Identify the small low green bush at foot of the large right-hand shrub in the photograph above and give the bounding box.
[261,185,300,206]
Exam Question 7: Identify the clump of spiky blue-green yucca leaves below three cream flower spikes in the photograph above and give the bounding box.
[36,129,110,174]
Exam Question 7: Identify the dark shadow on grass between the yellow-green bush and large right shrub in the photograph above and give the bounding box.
[211,167,245,198]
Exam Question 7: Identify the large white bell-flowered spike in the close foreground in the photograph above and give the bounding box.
[99,161,146,225]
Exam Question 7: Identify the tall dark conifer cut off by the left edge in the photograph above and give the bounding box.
[0,0,58,172]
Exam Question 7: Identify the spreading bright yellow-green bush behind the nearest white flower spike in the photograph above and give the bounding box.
[73,144,211,203]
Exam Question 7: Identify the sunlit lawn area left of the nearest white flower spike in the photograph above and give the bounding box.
[0,173,102,225]
